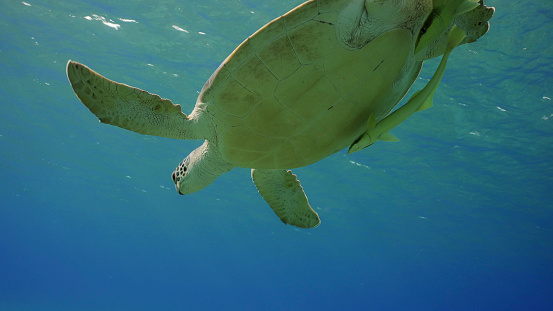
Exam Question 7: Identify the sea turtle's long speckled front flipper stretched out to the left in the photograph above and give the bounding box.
[67,60,203,139]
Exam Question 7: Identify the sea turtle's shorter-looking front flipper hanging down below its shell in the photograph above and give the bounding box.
[252,169,321,228]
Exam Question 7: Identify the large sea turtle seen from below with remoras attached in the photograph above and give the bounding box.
[67,0,493,228]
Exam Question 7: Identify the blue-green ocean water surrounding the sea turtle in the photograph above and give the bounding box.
[0,0,553,310]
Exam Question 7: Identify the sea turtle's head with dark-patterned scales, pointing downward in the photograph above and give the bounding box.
[171,141,233,194]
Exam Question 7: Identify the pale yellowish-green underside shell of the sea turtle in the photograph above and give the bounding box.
[199,1,411,169]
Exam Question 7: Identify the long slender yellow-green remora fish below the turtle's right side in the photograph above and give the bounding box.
[348,26,465,153]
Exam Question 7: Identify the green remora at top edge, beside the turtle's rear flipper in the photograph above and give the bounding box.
[415,0,479,54]
